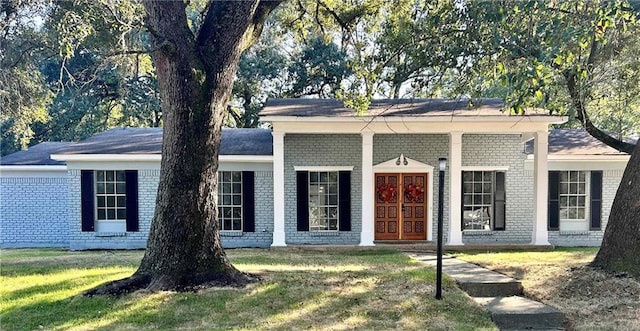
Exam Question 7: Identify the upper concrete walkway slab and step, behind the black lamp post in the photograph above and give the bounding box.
[409,254,522,297]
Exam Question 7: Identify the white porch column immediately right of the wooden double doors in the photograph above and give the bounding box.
[447,132,463,245]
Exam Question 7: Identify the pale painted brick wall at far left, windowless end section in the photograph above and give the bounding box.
[0,175,69,248]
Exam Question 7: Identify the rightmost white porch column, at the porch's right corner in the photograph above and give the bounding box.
[531,131,549,245]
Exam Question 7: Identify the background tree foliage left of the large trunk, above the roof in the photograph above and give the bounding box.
[0,0,161,155]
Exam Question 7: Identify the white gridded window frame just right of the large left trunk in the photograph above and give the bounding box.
[217,170,245,232]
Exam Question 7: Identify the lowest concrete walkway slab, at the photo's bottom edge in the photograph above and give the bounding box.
[473,296,565,330]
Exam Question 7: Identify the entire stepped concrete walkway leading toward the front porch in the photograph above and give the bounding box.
[407,252,564,330]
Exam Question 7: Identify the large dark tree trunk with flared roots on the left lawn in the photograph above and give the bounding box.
[86,0,277,295]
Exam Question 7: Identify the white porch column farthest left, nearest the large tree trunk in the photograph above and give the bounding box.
[271,131,287,247]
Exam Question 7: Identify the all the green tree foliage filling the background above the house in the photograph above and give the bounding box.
[0,0,640,154]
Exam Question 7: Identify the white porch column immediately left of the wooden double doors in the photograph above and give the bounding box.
[360,132,374,246]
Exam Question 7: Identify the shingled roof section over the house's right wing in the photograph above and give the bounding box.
[526,129,626,155]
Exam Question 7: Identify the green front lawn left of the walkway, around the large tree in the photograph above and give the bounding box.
[0,248,495,330]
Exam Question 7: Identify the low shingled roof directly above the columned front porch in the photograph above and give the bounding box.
[260,99,548,117]
